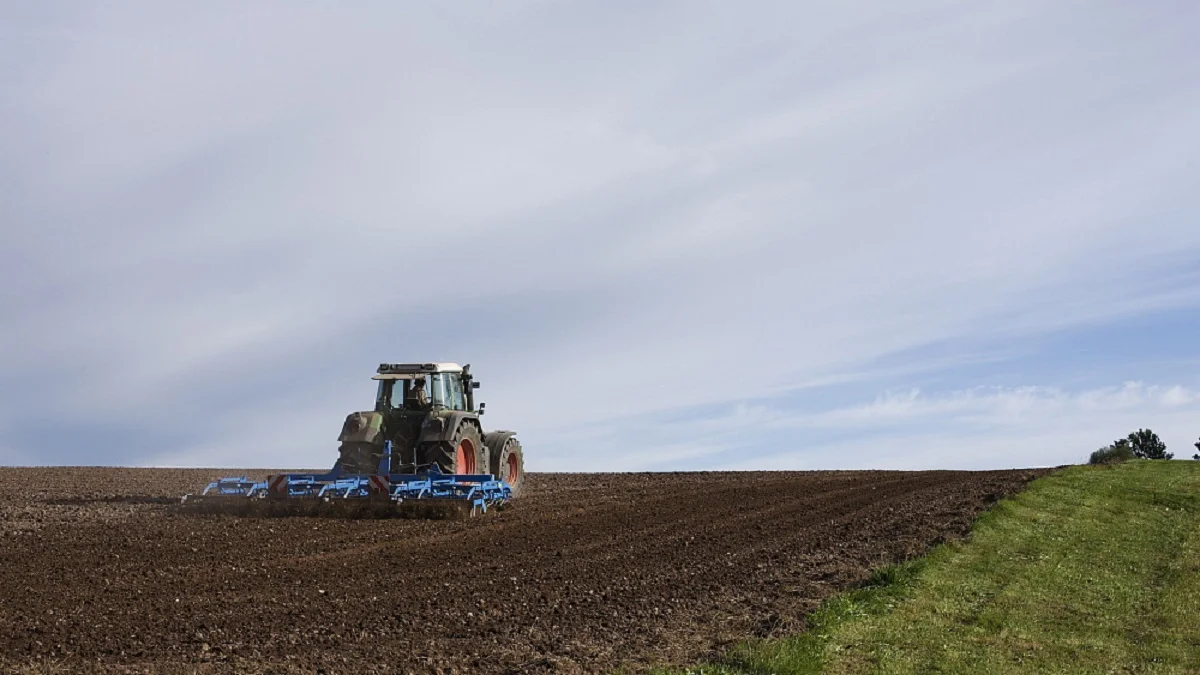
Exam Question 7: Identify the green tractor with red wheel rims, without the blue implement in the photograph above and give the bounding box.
[337,363,524,494]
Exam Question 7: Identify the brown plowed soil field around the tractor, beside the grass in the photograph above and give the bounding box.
[0,468,1042,673]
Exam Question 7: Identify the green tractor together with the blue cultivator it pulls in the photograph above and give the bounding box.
[180,363,524,516]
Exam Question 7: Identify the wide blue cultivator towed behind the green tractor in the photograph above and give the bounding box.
[180,441,512,516]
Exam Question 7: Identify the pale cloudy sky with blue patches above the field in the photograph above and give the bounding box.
[0,0,1200,471]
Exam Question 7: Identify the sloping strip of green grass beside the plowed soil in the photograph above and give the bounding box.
[666,461,1200,675]
